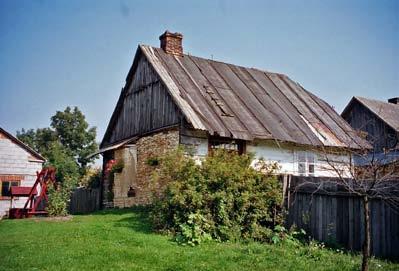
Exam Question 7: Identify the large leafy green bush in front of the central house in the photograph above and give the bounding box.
[152,150,282,244]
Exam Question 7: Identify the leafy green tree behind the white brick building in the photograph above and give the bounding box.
[17,106,98,181]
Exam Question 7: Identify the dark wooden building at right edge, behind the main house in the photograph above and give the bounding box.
[341,97,399,164]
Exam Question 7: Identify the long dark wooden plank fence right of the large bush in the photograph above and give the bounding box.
[285,176,399,259]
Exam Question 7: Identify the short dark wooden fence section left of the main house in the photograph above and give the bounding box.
[69,188,100,214]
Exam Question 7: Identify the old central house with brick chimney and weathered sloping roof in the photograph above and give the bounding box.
[96,32,368,207]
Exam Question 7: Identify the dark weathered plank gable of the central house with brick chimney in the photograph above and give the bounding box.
[104,55,181,145]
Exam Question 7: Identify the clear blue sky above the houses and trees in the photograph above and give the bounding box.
[0,0,399,141]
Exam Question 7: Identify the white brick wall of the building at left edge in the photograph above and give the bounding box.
[0,136,42,218]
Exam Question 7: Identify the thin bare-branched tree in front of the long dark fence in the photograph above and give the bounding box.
[295,148,399,271]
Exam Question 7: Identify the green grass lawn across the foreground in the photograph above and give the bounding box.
[0,208,399,271]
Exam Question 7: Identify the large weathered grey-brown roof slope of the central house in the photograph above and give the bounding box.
[140,45,369,148]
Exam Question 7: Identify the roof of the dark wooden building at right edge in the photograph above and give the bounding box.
[341,96,399,132]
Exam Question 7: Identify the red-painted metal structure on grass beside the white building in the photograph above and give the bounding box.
[9,168,55,218]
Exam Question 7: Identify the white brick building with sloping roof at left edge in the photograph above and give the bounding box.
[0,127,45,218]
